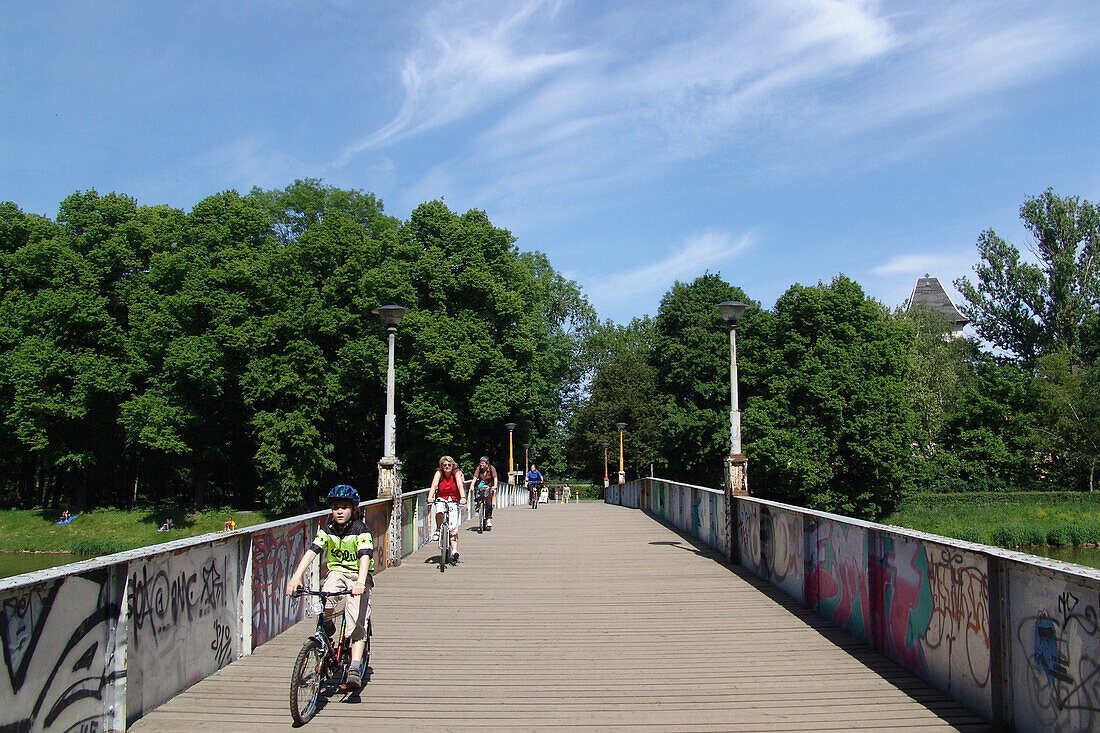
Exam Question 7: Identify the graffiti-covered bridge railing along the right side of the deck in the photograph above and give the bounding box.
[606,479,1100,731]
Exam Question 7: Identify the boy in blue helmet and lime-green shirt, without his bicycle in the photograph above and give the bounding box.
[286,484,374,690]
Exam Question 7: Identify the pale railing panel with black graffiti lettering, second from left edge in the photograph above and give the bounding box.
[127,541,241,722]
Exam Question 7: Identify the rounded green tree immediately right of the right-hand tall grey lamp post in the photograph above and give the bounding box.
[739,275,916,518]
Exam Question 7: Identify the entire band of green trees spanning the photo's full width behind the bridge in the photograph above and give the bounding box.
[0,180,1100,518]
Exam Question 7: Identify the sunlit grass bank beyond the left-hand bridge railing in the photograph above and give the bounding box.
[0,508,267,555]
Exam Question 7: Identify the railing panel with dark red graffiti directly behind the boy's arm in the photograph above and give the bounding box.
[252,522,312,648]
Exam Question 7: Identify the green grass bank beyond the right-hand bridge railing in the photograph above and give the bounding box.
[882,491,1100,547]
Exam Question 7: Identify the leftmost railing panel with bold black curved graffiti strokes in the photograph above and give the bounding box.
[0,568,125,731]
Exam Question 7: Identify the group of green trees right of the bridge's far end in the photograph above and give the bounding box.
[570,190,1100,518]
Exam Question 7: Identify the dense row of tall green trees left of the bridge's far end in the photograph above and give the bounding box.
[0,180,594,511]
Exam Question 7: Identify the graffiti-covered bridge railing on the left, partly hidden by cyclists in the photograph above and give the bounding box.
[0,484,527,731]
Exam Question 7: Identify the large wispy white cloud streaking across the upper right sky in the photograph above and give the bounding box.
[347,0,1100,211]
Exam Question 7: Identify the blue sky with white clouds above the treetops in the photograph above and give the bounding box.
[0,0,1100,322]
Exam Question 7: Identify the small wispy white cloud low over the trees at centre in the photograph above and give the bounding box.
[585,230,755,307]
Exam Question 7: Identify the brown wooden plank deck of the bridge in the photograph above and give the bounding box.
[131,502,990,733]
